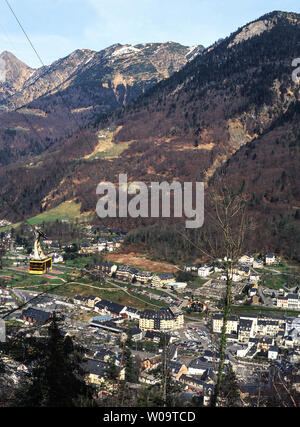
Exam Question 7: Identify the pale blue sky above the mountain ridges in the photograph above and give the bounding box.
[0,0,300,68]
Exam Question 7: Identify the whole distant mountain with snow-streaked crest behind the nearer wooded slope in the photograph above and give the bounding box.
[0,42,204,164]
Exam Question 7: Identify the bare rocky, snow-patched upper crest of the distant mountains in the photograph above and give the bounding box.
[0,42,204,111]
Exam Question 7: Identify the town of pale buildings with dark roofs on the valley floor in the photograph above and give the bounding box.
[0,226,300,406]
